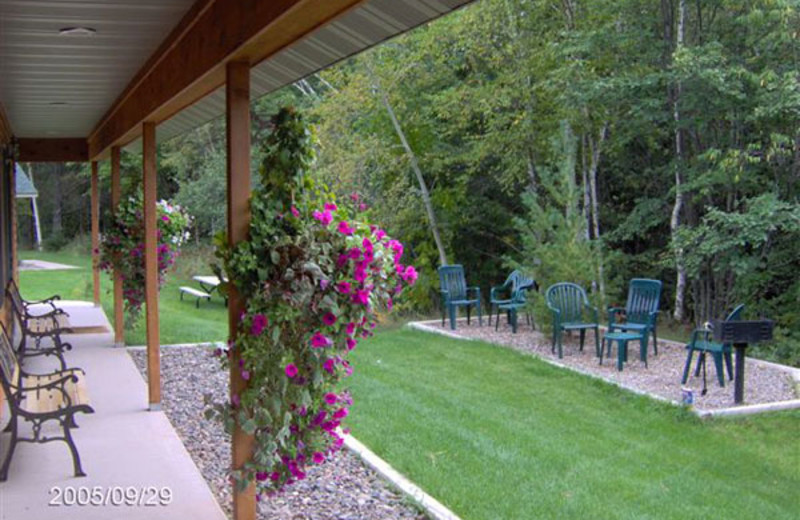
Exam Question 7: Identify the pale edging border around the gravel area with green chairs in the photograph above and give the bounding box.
[406,318,800,418]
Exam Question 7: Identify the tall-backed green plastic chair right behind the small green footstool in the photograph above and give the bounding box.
[608,278,661,355]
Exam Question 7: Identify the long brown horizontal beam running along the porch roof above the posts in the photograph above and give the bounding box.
[89,0,363,158]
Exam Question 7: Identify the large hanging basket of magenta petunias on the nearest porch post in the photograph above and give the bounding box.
[207,109,417,493]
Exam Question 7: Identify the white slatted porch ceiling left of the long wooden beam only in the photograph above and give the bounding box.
[0,0,194,137]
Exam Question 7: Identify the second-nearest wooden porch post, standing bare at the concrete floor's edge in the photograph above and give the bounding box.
[142,122,161,410]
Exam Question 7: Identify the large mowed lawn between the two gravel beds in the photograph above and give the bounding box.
[347,330,800,520]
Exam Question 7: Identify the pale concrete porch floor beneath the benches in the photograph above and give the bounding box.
[0,302,226,520]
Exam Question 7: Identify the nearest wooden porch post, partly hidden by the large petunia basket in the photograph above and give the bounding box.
[225,62,256,520]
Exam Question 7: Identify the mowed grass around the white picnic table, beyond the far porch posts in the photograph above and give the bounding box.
[20,251,228,345]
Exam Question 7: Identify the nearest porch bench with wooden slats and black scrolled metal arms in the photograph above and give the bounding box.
[0,324,94,482]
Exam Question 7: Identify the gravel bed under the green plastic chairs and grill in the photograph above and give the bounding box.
[423,316,800,410]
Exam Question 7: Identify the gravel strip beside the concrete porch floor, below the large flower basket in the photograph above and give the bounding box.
[128,347,427,520]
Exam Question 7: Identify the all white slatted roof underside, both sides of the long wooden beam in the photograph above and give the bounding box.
[0,0,472,156]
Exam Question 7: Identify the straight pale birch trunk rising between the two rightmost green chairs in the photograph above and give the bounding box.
[669,0,686,321]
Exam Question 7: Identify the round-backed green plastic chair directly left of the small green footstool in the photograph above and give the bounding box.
[545,282,601,359]
